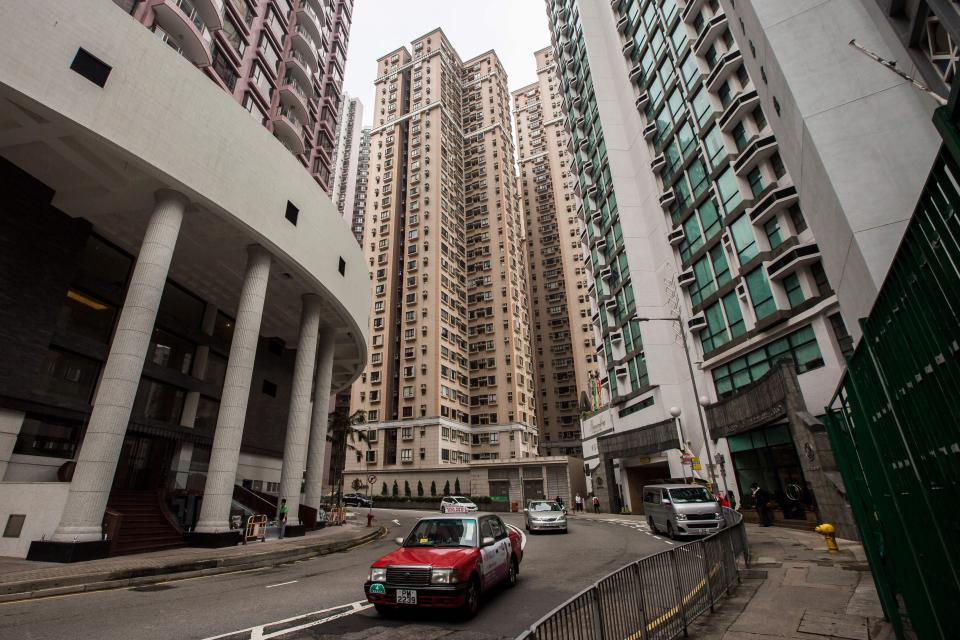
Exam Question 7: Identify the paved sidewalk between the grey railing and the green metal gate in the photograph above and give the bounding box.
[689,524,894,640]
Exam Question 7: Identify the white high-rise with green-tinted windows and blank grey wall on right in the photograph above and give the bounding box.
[546,0,936,522]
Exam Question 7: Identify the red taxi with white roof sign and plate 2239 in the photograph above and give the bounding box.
[363,515,523,617]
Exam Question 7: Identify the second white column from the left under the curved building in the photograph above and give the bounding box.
[195,245,270,533]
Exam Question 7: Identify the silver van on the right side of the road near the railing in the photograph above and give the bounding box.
[643,484,724,538]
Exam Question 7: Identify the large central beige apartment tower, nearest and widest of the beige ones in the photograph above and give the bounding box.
[346,29,538,486]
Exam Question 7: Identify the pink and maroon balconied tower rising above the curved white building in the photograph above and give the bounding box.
[124,0,353,193]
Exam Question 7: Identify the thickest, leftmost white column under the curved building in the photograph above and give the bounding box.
[53,189,189,542]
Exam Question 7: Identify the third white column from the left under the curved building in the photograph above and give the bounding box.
[277,295,320,527]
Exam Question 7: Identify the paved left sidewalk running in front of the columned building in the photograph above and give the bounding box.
[0,523,386,603]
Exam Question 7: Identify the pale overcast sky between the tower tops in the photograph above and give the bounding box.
[344,0,550,124]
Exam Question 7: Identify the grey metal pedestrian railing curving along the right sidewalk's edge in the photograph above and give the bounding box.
[517,508,750,640]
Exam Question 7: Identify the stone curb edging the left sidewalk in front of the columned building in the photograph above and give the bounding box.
[0,527,387,604]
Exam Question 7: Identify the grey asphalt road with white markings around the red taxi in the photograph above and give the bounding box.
[0,510,670,640]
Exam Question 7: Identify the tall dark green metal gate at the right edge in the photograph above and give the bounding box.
[826,109,960,638]
